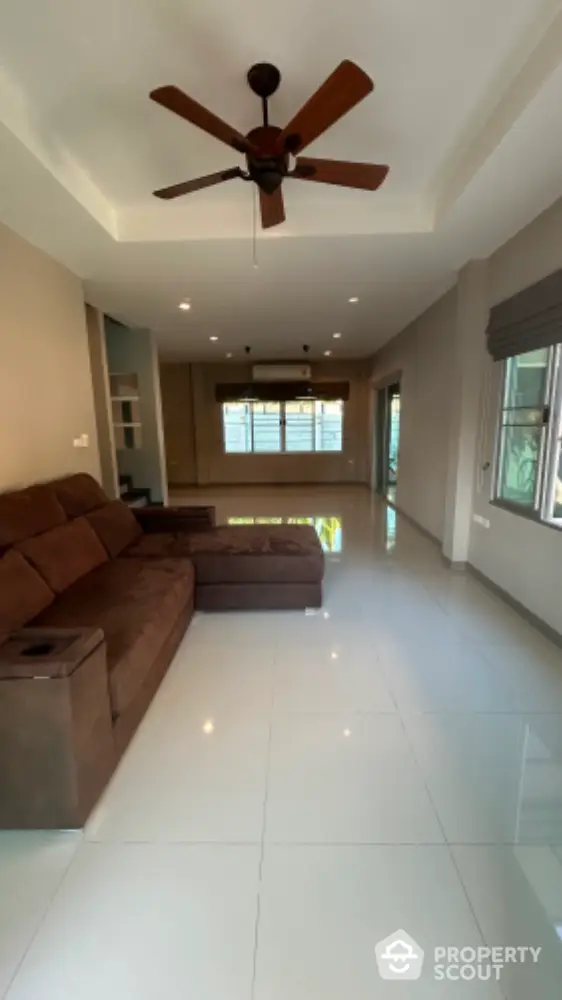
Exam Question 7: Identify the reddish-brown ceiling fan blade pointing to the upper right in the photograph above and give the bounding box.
[277,59,374,153]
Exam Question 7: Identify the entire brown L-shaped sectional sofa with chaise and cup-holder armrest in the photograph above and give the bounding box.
[0,475,323,828]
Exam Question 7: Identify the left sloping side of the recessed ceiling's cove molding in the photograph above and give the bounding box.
[0,69,118,239]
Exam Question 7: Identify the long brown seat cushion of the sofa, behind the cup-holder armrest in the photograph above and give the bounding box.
[34,559,194,716]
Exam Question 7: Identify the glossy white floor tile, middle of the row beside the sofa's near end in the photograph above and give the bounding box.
[266,714,443,844]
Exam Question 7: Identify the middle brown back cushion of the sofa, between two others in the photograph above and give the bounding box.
[17,517,107,594]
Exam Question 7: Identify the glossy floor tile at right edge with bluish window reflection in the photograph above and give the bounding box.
[405,714,562,844]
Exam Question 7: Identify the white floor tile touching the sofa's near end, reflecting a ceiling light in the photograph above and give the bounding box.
[86,712,269,843]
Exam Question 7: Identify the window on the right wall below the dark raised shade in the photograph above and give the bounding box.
[496,346,562,525]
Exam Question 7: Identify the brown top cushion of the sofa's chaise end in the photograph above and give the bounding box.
[186,524,324,584]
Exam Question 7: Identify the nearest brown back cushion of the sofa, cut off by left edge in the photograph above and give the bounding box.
[0,549,55,636]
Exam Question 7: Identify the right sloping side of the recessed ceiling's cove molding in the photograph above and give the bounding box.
[433,0,562,225]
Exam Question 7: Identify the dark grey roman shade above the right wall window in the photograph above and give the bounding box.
[487,271,562,361]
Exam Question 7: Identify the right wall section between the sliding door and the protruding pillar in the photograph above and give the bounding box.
[373,289,456,540]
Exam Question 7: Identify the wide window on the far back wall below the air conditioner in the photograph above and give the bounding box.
[222,399,344,454]
